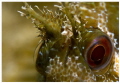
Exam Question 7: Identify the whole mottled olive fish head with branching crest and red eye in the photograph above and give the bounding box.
[18,2,119,82]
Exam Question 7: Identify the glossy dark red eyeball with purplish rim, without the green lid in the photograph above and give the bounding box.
[86,35,113,70]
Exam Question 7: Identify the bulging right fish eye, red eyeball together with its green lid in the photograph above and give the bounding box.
[80,30,113,70]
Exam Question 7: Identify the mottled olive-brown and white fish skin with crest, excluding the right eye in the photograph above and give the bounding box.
[20,2,119,82]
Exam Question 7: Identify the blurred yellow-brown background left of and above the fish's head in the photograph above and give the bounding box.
[2,2,56,82]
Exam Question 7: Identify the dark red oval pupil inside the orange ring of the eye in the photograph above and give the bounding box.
[91,46,105,65]
